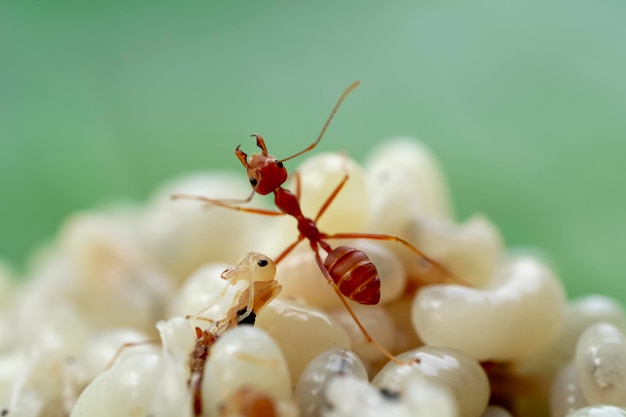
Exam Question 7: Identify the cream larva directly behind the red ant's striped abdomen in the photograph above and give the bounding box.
[276,239,407,310]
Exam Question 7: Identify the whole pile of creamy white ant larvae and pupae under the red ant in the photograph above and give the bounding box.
[0,139,626,417]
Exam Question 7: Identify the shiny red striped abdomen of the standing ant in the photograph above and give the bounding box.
[324,246,380,305]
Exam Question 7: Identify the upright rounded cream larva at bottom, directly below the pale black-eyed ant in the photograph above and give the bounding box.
[202,326,291,415]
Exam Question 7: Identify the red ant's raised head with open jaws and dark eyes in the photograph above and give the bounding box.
[235,135,287,195]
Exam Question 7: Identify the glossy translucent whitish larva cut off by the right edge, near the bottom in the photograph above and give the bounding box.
[575,323,626,407]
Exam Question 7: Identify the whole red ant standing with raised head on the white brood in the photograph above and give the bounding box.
[172,81,453,362]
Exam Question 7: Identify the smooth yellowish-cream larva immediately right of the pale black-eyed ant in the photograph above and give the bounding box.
[255,299,351,381]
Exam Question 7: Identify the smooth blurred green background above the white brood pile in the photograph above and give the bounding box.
[0,0,626,300]
